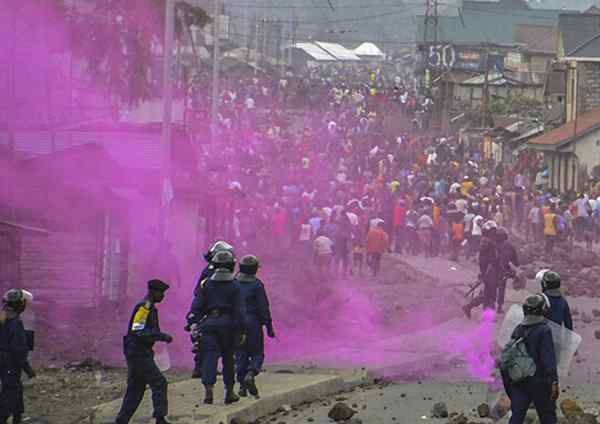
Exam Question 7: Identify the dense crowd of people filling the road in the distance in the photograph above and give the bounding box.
[193,62,600,273]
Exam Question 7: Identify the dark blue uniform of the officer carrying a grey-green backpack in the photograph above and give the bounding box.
[502,322,558,424]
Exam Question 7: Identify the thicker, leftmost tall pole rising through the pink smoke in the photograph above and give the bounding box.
[158,0,175,242]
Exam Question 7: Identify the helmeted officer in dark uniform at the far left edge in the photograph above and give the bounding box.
[0,289,35,424]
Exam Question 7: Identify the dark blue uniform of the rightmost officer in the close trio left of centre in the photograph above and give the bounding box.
[235,278,271,383]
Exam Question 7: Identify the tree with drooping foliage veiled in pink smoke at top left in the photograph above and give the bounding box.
[66,0,210,105]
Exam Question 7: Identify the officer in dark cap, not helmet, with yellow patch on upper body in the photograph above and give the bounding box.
[115,280,173,424]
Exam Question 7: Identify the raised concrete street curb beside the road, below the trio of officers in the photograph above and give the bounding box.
[209,371,375,424]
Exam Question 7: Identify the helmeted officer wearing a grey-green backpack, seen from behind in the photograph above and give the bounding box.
[502,294,559,424]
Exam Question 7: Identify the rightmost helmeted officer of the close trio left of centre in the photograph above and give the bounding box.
[236,255,275,397]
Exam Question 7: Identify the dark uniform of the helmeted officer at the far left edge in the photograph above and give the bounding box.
[0,317,29,424]
